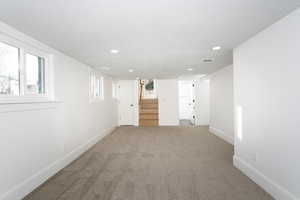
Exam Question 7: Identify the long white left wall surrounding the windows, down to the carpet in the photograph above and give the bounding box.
[0,22,117,200]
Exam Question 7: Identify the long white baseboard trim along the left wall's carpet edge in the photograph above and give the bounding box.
[0,127,116,200]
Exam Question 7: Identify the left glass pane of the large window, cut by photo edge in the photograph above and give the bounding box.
[0,42,20,95]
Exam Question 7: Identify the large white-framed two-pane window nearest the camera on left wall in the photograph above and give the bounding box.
[0,35,49,103]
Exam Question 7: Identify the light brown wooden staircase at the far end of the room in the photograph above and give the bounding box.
[139,99,158,126]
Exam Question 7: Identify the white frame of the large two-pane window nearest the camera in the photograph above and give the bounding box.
[0,33,53,104]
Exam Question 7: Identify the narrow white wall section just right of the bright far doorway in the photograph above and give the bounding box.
[195,78,210,126]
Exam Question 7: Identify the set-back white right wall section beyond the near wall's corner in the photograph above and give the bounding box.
[209,66,234,144]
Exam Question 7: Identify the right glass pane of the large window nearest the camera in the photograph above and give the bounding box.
[25,54,45,94]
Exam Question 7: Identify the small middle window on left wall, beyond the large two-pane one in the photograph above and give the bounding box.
[90,71,104,101]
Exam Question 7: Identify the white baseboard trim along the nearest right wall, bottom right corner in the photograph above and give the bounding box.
[233,156,299,200]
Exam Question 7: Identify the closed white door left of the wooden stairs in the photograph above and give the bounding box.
[119,80,135,125]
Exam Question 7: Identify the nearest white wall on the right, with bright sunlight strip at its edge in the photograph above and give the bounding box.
[234,9,300,200]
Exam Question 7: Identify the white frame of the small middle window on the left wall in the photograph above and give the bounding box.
[89,70,104,103]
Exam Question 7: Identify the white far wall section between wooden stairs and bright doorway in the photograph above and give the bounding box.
[156,79,179,126]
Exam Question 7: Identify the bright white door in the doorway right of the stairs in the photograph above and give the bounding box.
[179,81,195,124]
